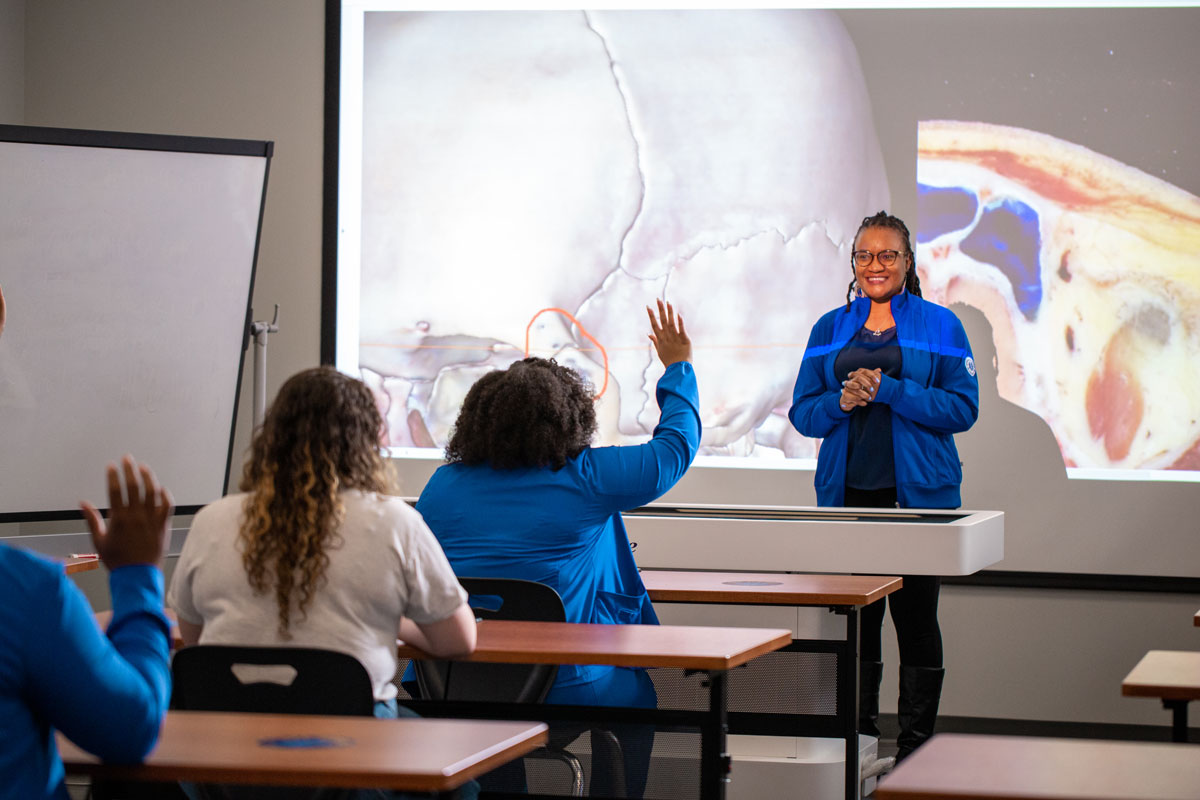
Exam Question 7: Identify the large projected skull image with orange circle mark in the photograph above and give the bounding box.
[348,11,889,465]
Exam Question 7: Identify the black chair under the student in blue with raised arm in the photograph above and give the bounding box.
[413,578,625,796]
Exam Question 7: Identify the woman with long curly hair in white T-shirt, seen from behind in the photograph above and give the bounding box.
[169,367,475,716]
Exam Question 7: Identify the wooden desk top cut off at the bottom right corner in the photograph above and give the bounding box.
[875,733,1200,800]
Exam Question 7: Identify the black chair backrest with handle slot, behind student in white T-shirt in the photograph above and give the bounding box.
[170,644,374,716]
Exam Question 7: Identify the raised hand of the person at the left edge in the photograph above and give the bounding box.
[79,456,173,570]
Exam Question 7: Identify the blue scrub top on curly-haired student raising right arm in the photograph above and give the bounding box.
[416,362,701,686]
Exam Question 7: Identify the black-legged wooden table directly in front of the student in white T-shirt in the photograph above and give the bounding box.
[400,620,792,800]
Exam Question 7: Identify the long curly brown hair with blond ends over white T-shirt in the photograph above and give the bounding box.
[240,367,395,639]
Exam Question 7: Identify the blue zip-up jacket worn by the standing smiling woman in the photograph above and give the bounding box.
[787,291,979,509]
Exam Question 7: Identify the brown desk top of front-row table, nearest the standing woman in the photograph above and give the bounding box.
[642,570,902,606]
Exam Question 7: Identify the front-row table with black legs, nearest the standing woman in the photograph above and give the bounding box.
[641,570,902,800]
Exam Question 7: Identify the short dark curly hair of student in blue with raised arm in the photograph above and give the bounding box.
[446,359,596,469]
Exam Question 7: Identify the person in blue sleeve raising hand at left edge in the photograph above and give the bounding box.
[0,455,172,800]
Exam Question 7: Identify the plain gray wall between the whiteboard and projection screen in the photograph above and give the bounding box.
[24,0,324,489]
